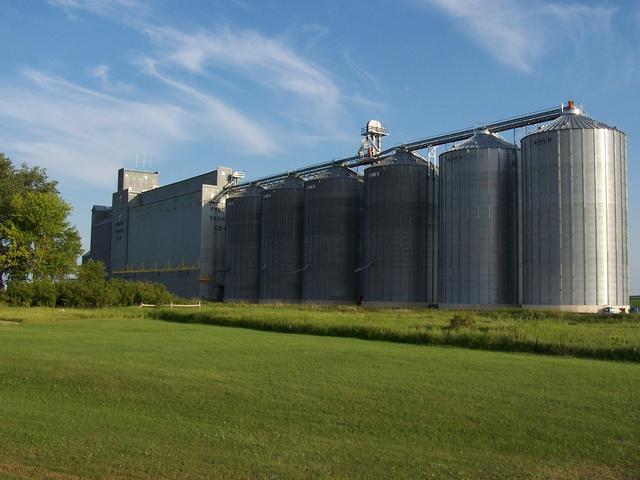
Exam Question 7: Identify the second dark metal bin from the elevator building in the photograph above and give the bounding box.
[260,176,304,302]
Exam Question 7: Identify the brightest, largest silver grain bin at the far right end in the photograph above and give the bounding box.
[521,106,629,311]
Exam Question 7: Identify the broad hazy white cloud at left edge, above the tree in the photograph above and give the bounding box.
[0,70,269,186]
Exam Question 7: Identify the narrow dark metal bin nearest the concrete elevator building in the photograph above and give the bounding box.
[224,185,264,302]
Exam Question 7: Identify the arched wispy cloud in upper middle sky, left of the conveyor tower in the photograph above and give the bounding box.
[143,25,358,141]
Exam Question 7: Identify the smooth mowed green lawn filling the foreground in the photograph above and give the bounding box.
[0,311,640,479]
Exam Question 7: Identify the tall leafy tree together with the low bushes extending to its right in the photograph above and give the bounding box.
[0,153,178,307]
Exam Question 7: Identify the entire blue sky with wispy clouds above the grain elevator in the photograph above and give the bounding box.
[0,0,640,293]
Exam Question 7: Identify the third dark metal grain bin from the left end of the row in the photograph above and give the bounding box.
[302,167,363,303]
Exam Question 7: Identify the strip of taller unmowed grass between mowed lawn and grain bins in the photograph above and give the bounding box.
[148,304,640,361]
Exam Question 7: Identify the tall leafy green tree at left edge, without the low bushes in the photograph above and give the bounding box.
[0,154,82,288]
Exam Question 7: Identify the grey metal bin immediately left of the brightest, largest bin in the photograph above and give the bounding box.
[438,130,518,306]
